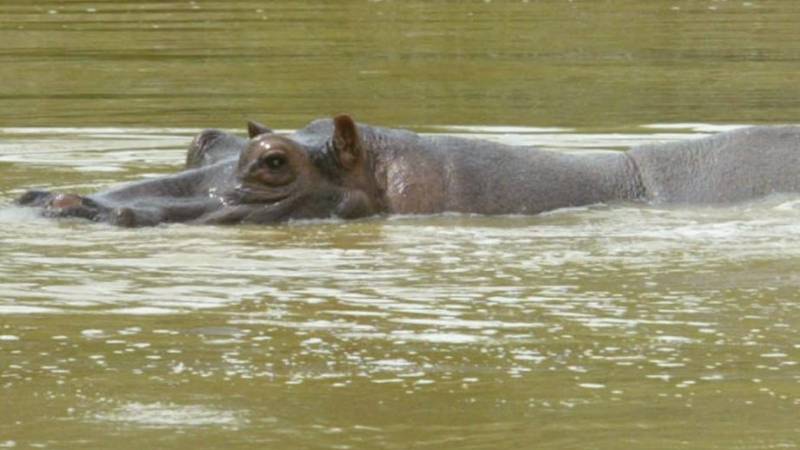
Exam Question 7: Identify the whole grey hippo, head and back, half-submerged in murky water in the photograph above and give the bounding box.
[18,115,800,226]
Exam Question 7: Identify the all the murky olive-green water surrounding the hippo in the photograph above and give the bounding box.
[0,0,800,449]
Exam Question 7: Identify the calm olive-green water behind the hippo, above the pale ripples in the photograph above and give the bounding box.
[0,0,800,128]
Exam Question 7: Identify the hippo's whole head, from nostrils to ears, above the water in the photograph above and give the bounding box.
[18,115,385,226]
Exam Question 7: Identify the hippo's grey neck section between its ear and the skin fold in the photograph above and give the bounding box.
[362,127,644,214]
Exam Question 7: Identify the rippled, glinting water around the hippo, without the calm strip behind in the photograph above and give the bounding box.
[0,128,800,448]
